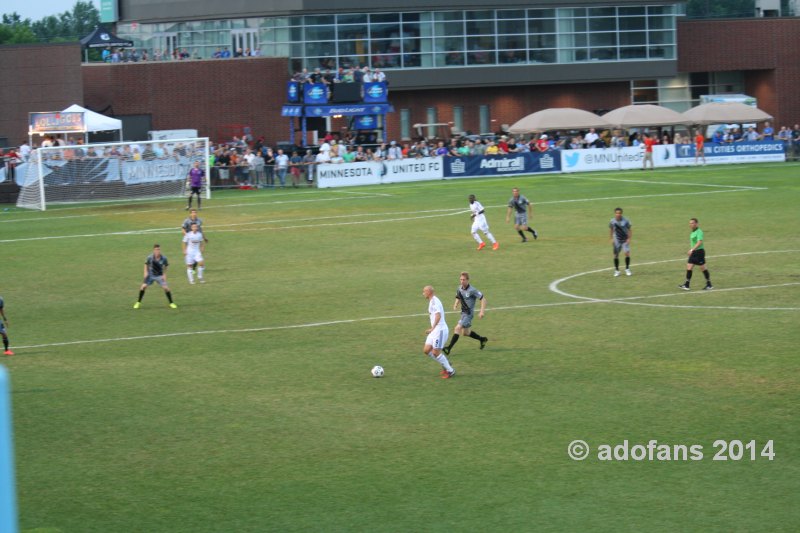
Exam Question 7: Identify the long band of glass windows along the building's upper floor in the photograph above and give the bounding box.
[118,4,682,69]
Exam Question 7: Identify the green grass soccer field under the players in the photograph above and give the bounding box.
[0,163,800,533]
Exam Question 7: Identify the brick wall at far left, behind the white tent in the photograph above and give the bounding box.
[0,44,83,146]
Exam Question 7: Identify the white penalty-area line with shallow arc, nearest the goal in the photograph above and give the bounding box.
[0,189,764,244]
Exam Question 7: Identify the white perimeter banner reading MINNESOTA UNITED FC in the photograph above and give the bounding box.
[317,157,444,189]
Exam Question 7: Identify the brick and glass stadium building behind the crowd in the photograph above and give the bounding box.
[0,0,800,143]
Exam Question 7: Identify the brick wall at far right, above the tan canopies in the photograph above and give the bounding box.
[678,18,800,131]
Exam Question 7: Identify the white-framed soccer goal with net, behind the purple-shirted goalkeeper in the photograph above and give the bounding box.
[17,138,211,211]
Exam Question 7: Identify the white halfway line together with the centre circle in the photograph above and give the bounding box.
[14,250,800,350]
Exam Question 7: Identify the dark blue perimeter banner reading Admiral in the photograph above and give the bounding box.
[444,152,561,178]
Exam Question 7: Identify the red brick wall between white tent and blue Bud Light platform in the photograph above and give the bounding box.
[82,58,289,142]
